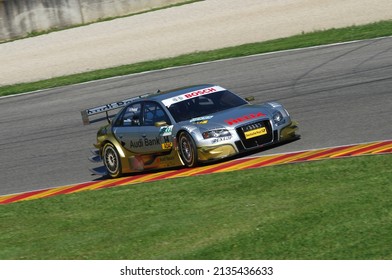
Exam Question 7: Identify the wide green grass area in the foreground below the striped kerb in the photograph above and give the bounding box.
[0,155,392,260]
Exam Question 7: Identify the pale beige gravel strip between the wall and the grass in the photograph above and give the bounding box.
[0,0,392,85]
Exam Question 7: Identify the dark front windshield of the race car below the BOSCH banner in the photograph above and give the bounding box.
[168,90,247,122]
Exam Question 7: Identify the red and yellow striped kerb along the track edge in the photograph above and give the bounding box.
[0,140,392,204]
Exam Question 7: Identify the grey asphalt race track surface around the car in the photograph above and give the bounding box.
[0,37,392,195]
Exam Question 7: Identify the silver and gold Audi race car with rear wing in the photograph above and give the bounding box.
[81,84,299,178]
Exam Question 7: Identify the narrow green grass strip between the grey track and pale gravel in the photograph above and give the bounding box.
[0,21,392,96]
